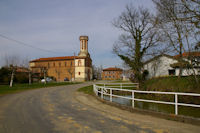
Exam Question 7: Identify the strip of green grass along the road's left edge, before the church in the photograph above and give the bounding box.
[0,82,78,95]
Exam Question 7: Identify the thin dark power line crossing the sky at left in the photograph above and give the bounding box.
[0,34,63,54]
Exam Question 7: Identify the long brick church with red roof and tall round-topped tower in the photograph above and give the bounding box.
[29,36,92,82]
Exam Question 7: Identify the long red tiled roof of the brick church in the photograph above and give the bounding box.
[30,56,84,62]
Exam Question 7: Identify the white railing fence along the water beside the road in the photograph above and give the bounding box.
[93,83,200,115]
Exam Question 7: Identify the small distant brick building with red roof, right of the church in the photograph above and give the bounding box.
[102,68,123,80]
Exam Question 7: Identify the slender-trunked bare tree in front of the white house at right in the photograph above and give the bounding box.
[153,0,197,77]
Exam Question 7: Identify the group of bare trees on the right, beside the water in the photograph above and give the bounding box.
[112,0,200,83]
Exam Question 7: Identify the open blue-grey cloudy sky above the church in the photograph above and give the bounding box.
[0,0,154,68]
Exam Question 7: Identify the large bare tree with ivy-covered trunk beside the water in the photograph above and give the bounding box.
[113,5,161,83]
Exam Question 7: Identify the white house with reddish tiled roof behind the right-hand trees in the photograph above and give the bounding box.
[144,52,200,78]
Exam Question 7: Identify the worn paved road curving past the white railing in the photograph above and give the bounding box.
[0,83,200,133]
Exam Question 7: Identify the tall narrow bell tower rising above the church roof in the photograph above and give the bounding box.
[78,36,89,57]
